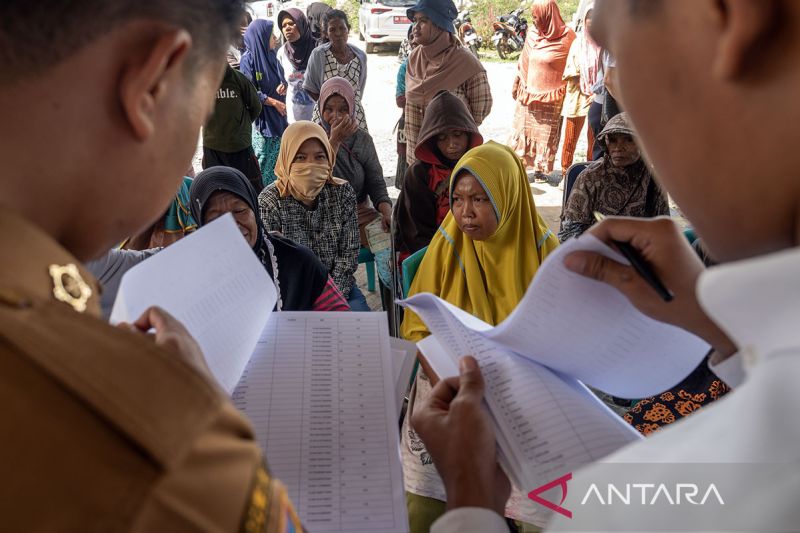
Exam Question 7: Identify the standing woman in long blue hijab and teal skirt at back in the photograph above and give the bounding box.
[240,19,289,187]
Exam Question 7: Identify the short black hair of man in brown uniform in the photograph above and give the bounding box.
[0,0,244,85]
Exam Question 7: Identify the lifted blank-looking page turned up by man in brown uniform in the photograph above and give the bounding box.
[111,214,278,393]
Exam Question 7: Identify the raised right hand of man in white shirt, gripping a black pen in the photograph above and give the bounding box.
[564,217,735,358]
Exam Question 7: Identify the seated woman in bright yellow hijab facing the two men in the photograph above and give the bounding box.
[401,142,558,533]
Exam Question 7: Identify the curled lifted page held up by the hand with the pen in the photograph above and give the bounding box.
[404,234,710,399]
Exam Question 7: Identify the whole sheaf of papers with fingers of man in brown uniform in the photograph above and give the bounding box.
[112,215,415,533]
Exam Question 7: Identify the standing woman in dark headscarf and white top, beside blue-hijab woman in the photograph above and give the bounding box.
[278,8,317,124]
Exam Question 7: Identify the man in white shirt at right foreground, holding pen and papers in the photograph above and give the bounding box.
[412,0,800,533]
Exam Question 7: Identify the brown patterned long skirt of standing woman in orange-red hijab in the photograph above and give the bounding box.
[511,100,564,174]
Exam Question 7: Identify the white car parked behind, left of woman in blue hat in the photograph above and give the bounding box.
[358,0,416,54]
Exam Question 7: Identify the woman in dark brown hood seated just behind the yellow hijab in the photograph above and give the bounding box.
[394,91,483,260]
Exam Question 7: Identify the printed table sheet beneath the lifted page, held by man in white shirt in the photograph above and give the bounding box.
[418,332,642,498]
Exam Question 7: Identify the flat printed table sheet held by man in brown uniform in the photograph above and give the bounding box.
[233,312,408,533]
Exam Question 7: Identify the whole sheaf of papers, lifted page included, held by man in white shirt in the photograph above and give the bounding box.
[396,236,708,502]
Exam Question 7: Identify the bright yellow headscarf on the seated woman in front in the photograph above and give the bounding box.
[401,142,558,342]
